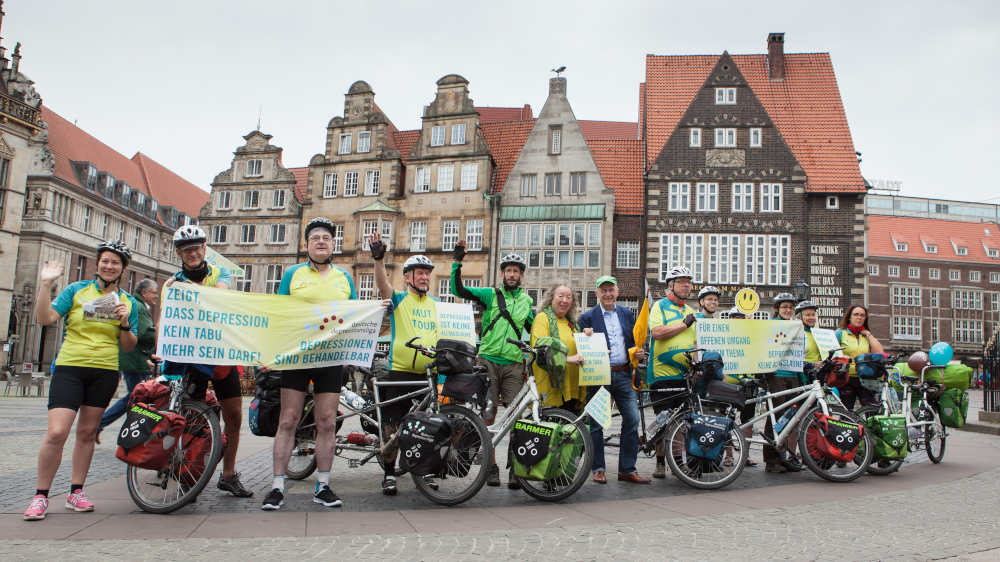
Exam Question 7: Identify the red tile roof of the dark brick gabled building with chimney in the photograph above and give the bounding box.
[640,53,865,192]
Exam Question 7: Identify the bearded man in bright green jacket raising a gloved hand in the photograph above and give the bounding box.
[451,241,535,488]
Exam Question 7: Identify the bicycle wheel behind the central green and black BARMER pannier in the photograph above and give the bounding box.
[514,408,594,502]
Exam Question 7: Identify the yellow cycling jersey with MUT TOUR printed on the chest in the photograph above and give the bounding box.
[389,291,438,373]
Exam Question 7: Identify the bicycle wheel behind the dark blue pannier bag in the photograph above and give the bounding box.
[661,410,750,490]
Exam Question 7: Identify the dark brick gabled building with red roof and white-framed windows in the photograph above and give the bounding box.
[640,33,865,327]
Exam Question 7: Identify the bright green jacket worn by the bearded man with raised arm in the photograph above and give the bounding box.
[451,262,535,365]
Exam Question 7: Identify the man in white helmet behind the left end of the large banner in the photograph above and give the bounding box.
[164,224,253,498]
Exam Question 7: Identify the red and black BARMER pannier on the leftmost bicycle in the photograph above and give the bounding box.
[115,402,186,470]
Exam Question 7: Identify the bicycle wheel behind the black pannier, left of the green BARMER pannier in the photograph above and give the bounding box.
[412,404,493,505]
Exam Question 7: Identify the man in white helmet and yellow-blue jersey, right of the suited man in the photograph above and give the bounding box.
[646,265,697,478]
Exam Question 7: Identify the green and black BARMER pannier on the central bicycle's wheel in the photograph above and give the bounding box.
[510,420,578,481]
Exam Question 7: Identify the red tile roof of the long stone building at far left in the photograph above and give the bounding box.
[42,106,208,217]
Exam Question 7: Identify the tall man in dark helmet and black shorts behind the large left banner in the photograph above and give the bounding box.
[261,217,358,511]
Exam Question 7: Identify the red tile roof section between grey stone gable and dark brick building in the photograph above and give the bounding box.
[587,138,643,215]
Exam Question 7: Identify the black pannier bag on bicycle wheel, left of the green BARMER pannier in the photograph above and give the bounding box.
[399,412,451,476]
